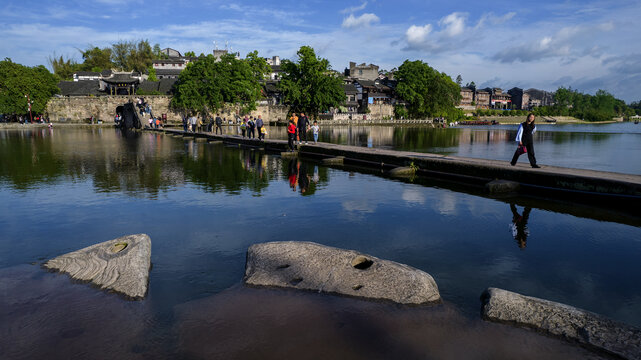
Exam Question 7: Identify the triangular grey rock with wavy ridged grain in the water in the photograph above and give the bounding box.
[44,234,151,299]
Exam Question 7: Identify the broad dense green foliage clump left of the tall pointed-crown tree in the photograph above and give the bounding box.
[171,53,268,113]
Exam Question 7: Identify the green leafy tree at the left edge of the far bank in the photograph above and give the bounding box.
[0,58,59,115]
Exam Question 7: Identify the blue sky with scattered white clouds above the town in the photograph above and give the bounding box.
[0,0,641,103]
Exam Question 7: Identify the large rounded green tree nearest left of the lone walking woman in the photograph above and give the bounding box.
[396,60,461,118]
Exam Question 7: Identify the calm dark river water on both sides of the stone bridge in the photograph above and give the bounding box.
[0,124,641,359]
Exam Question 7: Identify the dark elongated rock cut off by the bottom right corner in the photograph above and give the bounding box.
[481,288,641,359]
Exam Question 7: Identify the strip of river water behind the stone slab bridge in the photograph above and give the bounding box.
[270,122,641,174]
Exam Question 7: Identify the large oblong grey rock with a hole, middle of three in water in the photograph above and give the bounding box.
[244,242,441,304]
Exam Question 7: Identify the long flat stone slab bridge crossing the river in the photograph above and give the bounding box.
[146,129,641,208]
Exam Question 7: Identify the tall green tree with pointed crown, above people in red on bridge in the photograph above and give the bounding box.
[279,46,345,117]
